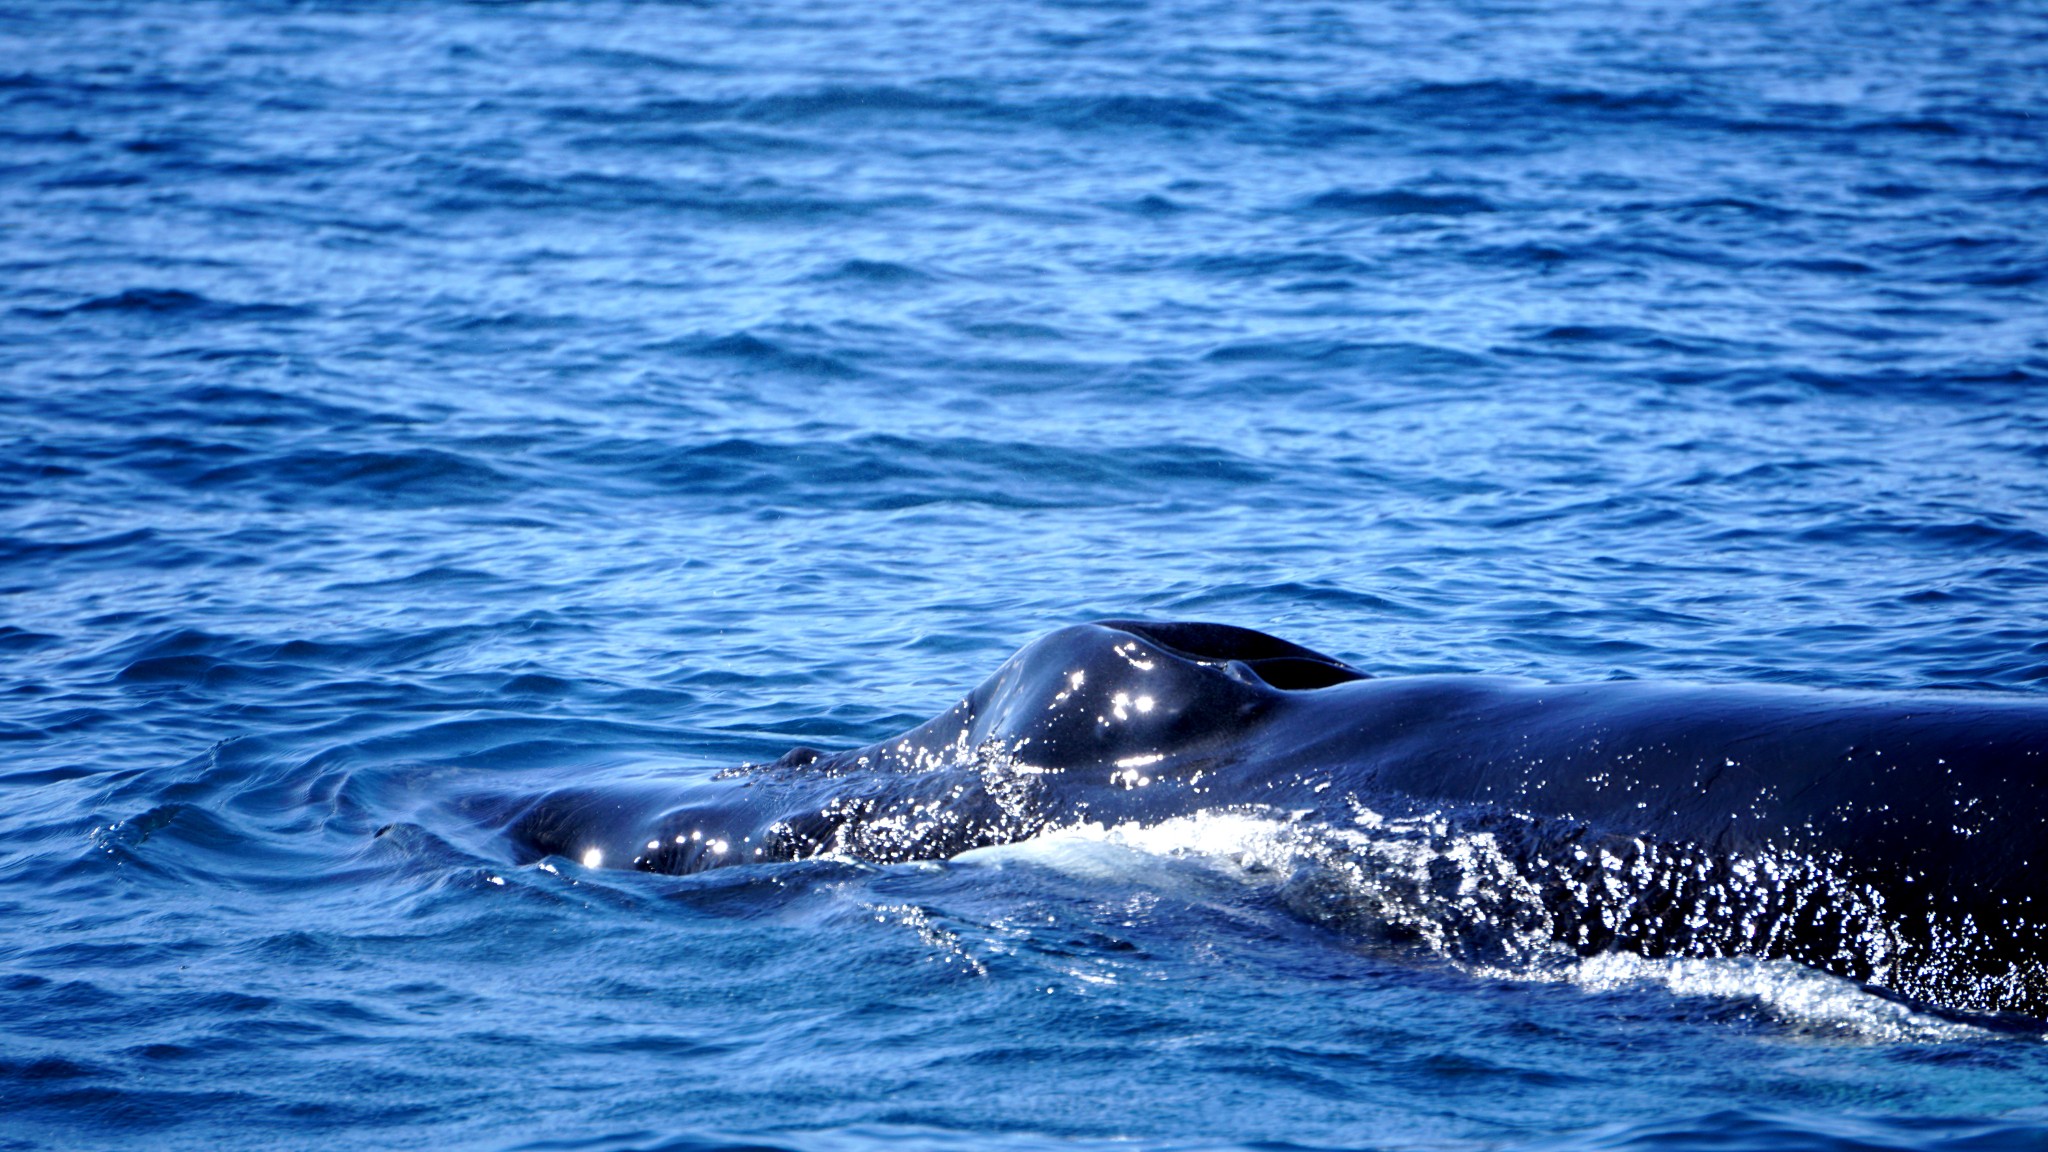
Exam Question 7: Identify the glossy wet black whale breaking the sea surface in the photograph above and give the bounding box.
[508,621,2048,1017]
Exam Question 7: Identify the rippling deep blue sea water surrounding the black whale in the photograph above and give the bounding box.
[0,0,2048,1152]
